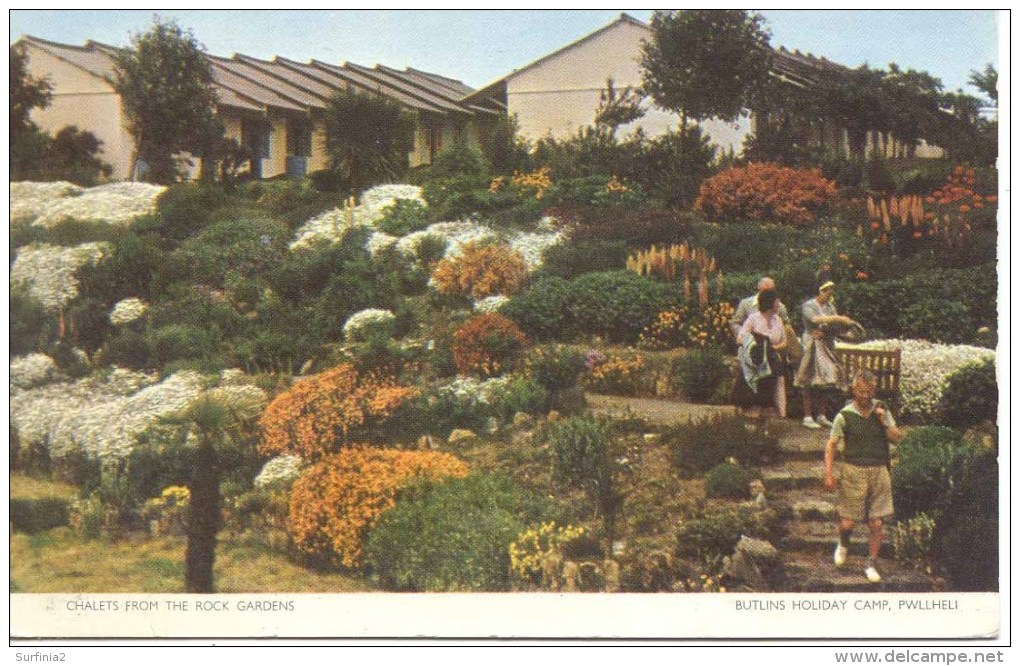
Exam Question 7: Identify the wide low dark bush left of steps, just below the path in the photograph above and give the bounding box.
[663,414,779,475]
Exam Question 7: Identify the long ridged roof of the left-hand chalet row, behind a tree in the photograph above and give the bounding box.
[18,36,481,117]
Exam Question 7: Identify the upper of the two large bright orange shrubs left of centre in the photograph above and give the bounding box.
[258,363,417,460]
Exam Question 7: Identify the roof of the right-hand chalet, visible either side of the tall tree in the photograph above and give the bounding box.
[461,13,847,108]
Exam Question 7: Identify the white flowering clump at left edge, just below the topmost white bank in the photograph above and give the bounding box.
[10,243,107,312]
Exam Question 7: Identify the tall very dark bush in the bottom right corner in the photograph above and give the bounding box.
[932,450,1000,592]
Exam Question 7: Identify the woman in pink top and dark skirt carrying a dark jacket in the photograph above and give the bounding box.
[734,290,787,418]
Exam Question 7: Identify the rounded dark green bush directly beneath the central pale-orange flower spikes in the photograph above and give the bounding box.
[567,270,672,343]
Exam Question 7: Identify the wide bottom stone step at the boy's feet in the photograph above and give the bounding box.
[783,555,946,593]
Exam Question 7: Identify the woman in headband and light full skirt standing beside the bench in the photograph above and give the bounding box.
[794,281,856,428]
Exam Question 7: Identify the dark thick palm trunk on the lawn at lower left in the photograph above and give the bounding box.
[185,432,219,594]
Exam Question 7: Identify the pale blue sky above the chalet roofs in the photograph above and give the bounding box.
[8,9,999,94]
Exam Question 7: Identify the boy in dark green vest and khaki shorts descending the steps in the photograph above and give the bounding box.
[825,371,902,583]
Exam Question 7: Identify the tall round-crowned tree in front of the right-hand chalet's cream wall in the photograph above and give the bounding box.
[641,9,772,133]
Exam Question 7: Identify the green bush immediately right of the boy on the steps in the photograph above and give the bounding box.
[893,425,974,522]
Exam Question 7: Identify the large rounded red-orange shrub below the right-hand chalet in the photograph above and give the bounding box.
[695,162,836,226]
